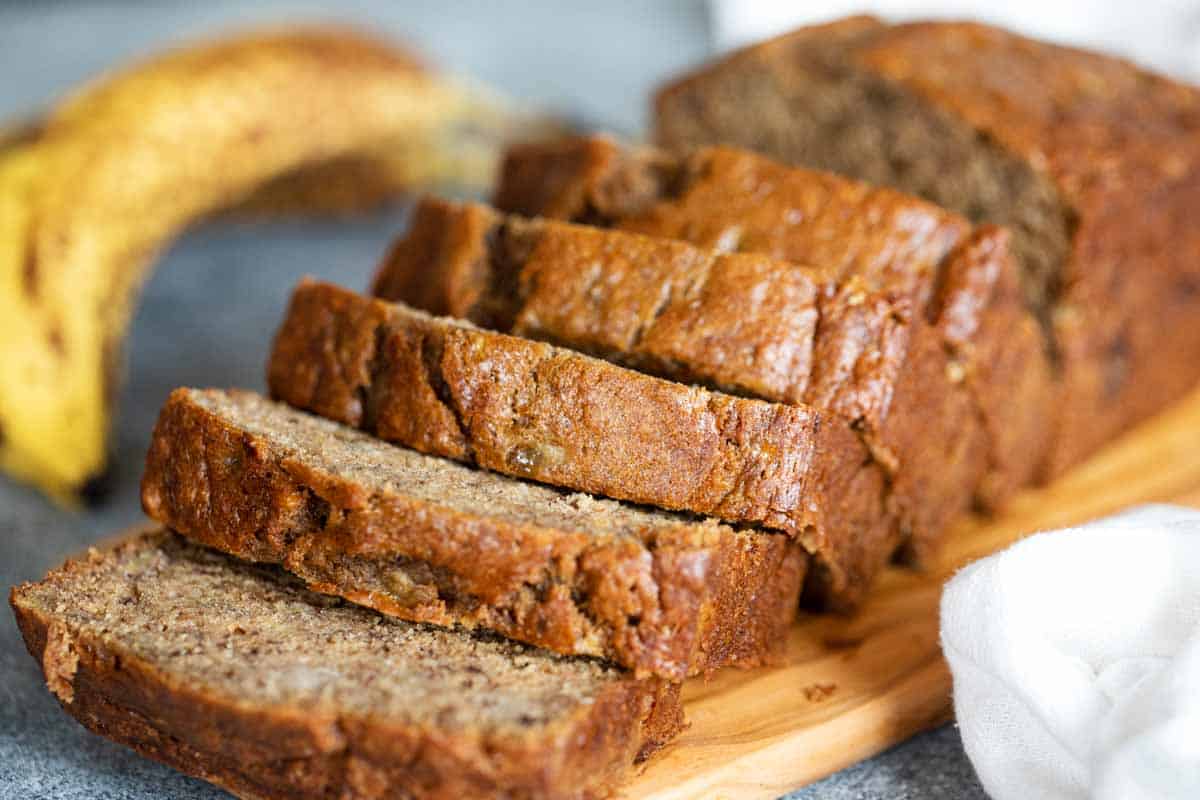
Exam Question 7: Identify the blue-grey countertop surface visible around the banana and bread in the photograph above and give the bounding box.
[0,0,984,800]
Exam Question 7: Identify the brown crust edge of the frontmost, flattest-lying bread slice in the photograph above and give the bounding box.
[10,531,682,800]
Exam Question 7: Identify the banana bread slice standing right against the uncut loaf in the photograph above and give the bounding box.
[487,136,1052,510]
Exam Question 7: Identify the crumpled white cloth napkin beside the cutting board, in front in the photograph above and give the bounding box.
[942,505,1200,800]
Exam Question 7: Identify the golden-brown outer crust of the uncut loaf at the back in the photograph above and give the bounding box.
[655,18,1200,479]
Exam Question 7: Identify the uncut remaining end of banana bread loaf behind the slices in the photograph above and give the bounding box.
[655,17,1200,475]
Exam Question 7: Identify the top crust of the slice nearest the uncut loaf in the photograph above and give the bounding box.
[493,136,973,291]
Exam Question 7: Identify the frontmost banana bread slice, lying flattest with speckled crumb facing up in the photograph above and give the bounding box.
[11,530,682,800]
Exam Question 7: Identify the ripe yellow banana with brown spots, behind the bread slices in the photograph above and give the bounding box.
[0,28,559,504]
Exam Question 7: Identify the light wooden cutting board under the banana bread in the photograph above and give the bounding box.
[625,383,1200,800]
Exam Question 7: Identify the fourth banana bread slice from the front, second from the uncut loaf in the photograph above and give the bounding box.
[374,192,986,573]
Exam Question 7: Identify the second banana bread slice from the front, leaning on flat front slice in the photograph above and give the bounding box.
[142,389,806,680]
